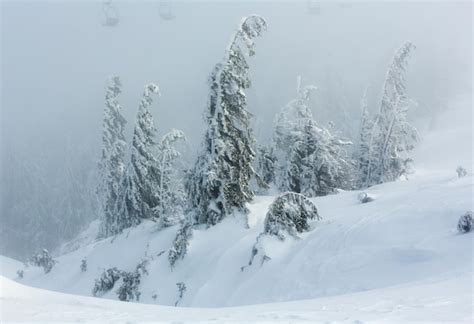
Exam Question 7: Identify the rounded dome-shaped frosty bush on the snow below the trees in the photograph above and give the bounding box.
[263,192,321,240]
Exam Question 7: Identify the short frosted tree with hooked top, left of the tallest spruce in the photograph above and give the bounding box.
[154,129,186,227]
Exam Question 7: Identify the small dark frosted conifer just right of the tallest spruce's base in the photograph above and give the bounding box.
[255,145,277,194]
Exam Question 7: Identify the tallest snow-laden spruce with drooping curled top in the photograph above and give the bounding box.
[186,16,266,226]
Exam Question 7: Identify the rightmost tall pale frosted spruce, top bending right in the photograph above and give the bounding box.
[365,42,418,186]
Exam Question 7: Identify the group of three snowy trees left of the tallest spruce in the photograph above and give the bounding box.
[98,76,185,237]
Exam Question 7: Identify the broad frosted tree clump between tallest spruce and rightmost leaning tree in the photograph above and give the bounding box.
[273,82,353,197]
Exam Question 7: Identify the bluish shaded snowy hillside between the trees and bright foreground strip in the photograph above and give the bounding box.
[6,170,472,307]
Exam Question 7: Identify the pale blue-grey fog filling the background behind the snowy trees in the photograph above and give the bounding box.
[0,1,472,259]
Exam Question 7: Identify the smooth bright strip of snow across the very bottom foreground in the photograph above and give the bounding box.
[0,276,472,323]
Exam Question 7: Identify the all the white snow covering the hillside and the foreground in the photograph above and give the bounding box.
[1,94,474,323]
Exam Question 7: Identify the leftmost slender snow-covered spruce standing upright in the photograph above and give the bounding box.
[98,76,126,237]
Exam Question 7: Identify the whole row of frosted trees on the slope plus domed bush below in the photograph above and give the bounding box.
[99,15,417,267]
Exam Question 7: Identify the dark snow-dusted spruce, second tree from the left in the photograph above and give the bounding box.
[119,83,160,224]
